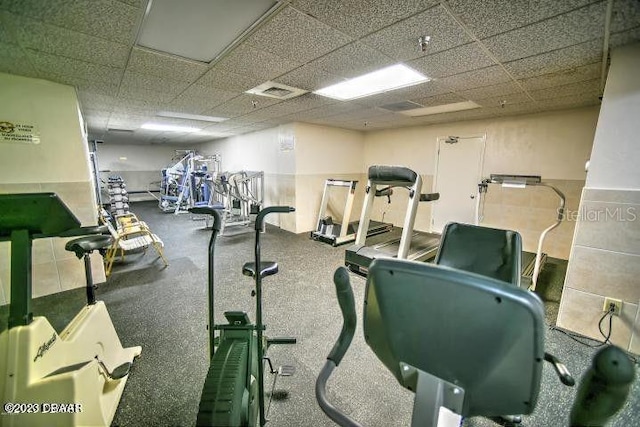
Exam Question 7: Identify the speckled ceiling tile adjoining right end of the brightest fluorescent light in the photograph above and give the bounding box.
[407,42,494,78]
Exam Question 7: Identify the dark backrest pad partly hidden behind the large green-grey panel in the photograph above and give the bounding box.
[434,223,522,286]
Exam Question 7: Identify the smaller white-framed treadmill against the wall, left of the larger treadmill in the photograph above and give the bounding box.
[310,179,393,246]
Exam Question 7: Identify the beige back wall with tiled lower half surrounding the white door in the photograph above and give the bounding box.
[364,108,598,259]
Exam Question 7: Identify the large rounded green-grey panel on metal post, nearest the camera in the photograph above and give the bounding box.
[363,258,544,416]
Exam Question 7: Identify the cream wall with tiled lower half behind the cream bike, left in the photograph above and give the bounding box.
[0,73,105,305]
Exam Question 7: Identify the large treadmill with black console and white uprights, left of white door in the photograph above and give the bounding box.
[345,165,440,276]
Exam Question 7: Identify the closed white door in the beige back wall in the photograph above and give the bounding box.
[431,136,485,233]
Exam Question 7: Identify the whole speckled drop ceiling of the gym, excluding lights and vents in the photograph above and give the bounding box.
[0,0,640,144]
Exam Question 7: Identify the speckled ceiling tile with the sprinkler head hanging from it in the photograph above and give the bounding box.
[362,6,471,61]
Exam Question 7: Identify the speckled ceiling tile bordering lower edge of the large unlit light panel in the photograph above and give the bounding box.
[127,47,209,82]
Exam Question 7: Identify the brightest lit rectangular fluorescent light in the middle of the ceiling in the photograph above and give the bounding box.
[314,64,430,101]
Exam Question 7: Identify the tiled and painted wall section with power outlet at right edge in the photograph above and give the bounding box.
[557,44,640,354]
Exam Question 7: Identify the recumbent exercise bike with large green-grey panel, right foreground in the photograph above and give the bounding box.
[316,226,635,427]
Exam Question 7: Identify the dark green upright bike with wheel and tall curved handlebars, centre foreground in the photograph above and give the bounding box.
[189,206,296,427]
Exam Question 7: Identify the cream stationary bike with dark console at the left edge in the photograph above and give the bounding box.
[0,193,142,426]
